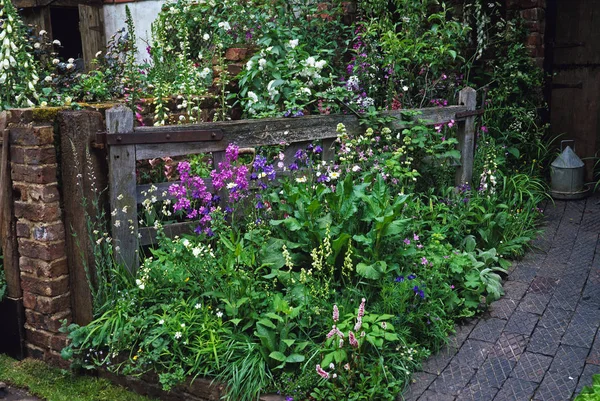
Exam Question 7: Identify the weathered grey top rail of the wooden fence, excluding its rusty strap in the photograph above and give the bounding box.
[136,106,467,160]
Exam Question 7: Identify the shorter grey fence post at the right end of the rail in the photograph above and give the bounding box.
[455,87,477,186]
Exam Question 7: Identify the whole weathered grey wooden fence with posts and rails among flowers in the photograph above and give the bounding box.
[99,88,480,270]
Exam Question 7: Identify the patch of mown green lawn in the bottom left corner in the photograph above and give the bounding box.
[0,354,157,401]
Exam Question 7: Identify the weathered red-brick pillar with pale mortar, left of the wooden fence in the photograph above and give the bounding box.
[9,115,71,366]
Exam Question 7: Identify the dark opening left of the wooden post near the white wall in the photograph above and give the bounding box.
[50,7,83,60]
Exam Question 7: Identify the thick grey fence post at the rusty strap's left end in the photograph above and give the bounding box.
[106,105,139,273]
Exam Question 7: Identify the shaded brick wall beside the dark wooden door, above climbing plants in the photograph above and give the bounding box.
[506,0,546,68]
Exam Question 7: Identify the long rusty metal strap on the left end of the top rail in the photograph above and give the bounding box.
[96,129,223,146]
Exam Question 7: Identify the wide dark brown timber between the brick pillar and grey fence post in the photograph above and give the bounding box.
[58,110,108,325]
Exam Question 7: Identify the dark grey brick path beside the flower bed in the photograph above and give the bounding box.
[400,197,600,401]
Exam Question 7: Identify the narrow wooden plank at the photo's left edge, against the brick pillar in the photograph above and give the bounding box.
[0,111,23,299]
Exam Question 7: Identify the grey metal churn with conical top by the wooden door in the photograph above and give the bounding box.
[550,141,589,199]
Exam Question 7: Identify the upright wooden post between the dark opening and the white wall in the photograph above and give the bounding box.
[78,4,106,71]
